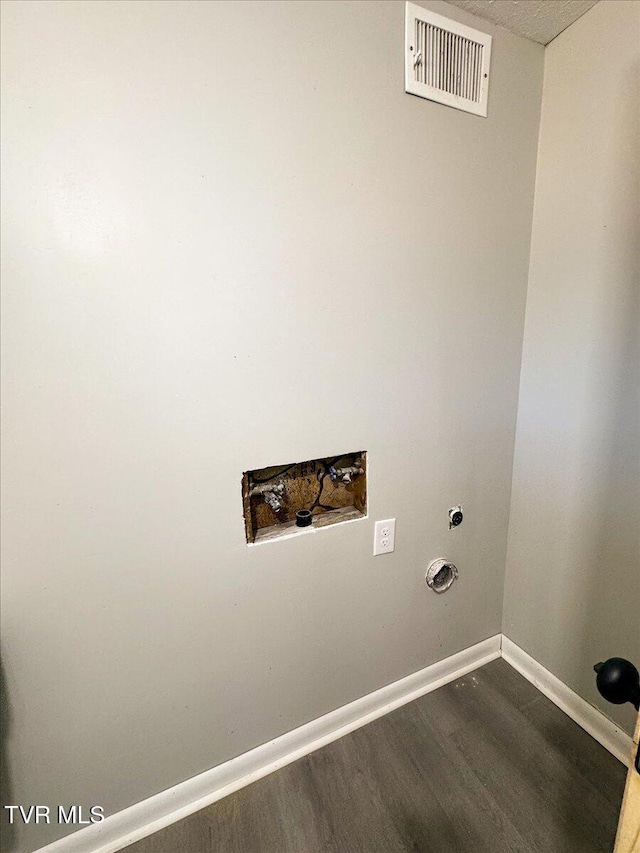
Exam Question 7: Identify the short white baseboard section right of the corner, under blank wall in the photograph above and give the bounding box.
[502,634,632,766]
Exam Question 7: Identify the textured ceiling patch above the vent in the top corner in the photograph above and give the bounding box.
[449,0,598,44]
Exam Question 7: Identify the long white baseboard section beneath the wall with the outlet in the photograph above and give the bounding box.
[38,634,501,853]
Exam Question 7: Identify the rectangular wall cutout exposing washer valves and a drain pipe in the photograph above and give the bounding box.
[242,450,367,544]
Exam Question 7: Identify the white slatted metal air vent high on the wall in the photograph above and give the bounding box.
[404,3,491,116]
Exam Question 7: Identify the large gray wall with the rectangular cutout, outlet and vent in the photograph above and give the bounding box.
[2,0,543,850]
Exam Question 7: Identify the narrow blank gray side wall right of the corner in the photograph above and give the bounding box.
[503,0,640,732]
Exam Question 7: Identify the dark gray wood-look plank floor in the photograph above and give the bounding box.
[127,660,625,853]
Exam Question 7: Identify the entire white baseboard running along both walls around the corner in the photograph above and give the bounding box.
[37,634,632,853]
